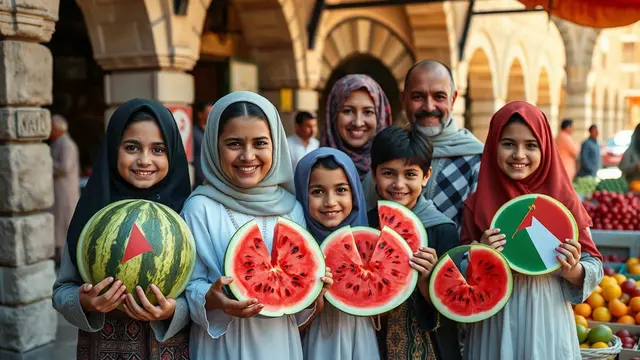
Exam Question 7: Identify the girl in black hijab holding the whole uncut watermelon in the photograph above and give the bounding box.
[53,99,191,359]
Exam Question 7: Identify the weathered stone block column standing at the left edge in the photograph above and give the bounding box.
[0,0,58,360]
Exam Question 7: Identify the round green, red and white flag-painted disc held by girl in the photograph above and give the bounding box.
[491,194,578,275]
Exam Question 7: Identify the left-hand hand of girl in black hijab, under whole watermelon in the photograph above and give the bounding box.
[80,277,127,313]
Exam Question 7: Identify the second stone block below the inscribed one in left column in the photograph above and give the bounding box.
[0,213,54,267]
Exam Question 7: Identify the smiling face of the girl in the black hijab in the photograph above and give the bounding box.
[118,119,169,189]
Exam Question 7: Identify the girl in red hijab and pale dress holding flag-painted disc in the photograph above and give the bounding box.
[461,101,602,360]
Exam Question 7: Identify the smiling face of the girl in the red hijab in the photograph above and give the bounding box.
[498,121,542,181]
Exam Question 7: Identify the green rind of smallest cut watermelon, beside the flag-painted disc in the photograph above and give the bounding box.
[429,244,513,323]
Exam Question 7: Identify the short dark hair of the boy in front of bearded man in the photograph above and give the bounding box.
[371,125,433,173]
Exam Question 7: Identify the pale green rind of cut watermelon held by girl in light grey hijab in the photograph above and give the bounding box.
[224,216,326,317]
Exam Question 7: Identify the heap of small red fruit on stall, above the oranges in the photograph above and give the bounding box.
[583,190,640,231]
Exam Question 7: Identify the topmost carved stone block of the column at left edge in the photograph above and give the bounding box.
[0,0,60,42]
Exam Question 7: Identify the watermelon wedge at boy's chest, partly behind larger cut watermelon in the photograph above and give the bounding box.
[378,200,429,252]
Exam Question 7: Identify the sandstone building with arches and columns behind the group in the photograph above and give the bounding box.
[0,0,640,359]
